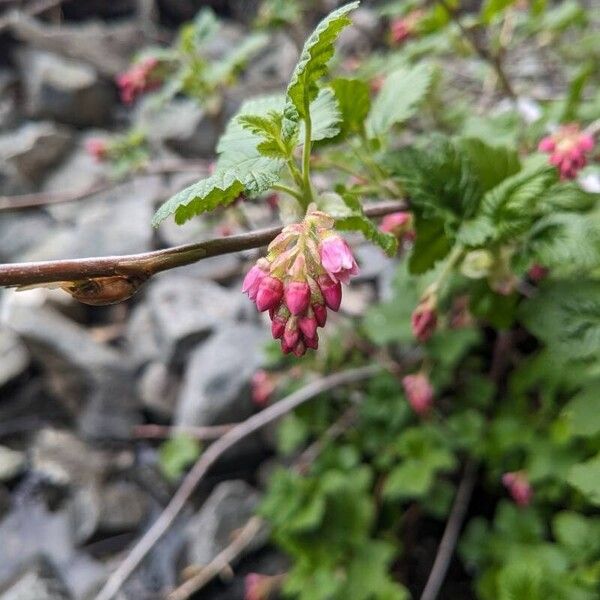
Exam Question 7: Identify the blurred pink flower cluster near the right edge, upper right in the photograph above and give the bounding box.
[538,123,594,179]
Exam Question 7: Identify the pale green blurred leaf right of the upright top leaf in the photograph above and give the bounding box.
[366,64,433,137]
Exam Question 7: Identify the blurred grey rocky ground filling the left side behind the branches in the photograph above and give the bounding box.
[0,0,387,600]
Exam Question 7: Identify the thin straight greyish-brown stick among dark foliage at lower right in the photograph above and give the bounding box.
[421,459,477,600]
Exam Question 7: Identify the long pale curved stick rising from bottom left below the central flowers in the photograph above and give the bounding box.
[95,365,381,600]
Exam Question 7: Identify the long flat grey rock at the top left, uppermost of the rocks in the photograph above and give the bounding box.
[11,15,144,78]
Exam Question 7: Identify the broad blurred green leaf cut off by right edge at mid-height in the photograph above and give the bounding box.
[520,279,600,359]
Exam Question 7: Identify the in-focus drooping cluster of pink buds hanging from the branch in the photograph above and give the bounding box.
[242,211,359,356]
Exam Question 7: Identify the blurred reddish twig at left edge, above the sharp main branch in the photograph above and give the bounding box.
[0,161,206,211]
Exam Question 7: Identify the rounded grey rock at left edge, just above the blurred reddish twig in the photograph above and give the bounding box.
[0,121,71,185]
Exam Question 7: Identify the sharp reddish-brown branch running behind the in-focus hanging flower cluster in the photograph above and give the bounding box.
[0,200,406,287]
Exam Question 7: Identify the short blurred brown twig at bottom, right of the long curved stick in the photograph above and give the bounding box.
[167,516,264,600]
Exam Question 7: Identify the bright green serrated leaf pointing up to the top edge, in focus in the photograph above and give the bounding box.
[287,2,359,118]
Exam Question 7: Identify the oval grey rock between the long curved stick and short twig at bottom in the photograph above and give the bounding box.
[187,480,266,565]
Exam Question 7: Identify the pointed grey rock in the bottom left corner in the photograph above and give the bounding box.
[0,560,72,600]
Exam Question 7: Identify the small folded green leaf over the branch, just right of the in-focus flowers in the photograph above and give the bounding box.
[317,193,398,256]
